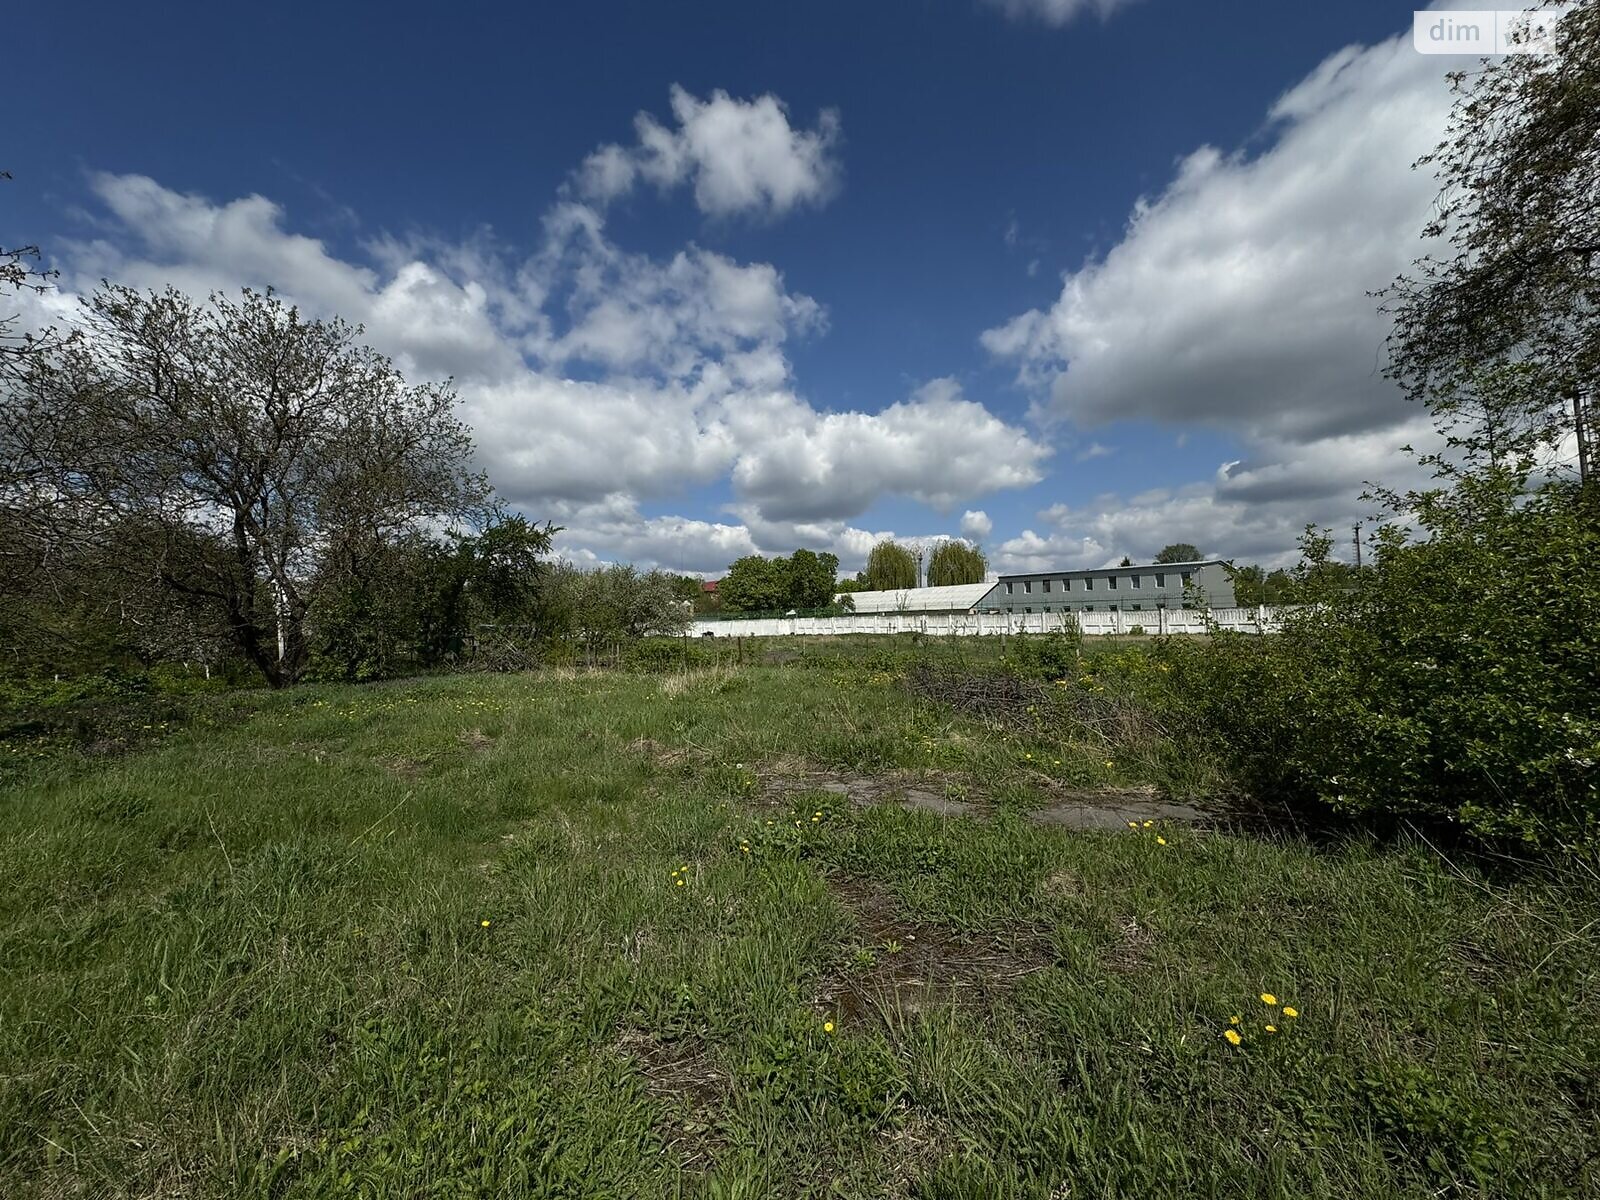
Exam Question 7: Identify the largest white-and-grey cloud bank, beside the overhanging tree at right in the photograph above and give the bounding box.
[981,24,1450,568]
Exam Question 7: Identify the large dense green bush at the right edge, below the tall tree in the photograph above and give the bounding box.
[1160,472,1600,850]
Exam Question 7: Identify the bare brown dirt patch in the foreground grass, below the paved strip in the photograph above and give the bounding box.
[813,878,1051,1021]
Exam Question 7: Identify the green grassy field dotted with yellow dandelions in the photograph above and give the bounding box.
[0,654,1600,1200]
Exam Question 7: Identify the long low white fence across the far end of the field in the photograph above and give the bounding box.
[691,608,1280,637]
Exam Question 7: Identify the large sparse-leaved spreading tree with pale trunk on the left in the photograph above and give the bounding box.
[0,285,490,686]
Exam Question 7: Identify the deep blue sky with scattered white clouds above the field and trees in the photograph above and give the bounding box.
[9,0,1454,574]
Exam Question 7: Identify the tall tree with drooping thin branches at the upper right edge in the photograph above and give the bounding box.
[1384,3,1600,483]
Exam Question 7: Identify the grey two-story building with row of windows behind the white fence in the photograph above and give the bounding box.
[976,558,1235,613]
